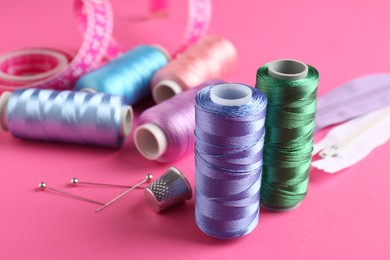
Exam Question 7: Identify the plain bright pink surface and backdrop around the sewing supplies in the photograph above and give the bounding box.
[0,0,390,259]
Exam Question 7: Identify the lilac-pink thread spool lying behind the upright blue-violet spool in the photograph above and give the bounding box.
[134,80,222,163]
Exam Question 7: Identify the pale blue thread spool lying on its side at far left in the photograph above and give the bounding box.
[0,88,133,148]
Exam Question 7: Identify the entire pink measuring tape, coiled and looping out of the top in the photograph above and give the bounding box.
[0,0,211,93]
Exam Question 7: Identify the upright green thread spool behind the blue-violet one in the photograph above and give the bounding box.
[256,60,319,211]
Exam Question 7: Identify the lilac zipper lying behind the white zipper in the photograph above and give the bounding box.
[314,73,390,132]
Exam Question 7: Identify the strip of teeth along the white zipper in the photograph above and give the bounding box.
[322,105,390,157]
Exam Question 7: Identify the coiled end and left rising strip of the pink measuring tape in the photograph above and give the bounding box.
[0,0,113,93]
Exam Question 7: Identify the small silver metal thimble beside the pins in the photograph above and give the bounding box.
[145,167,192,212]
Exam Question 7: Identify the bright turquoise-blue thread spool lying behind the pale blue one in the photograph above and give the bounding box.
[76,45,169,105]
